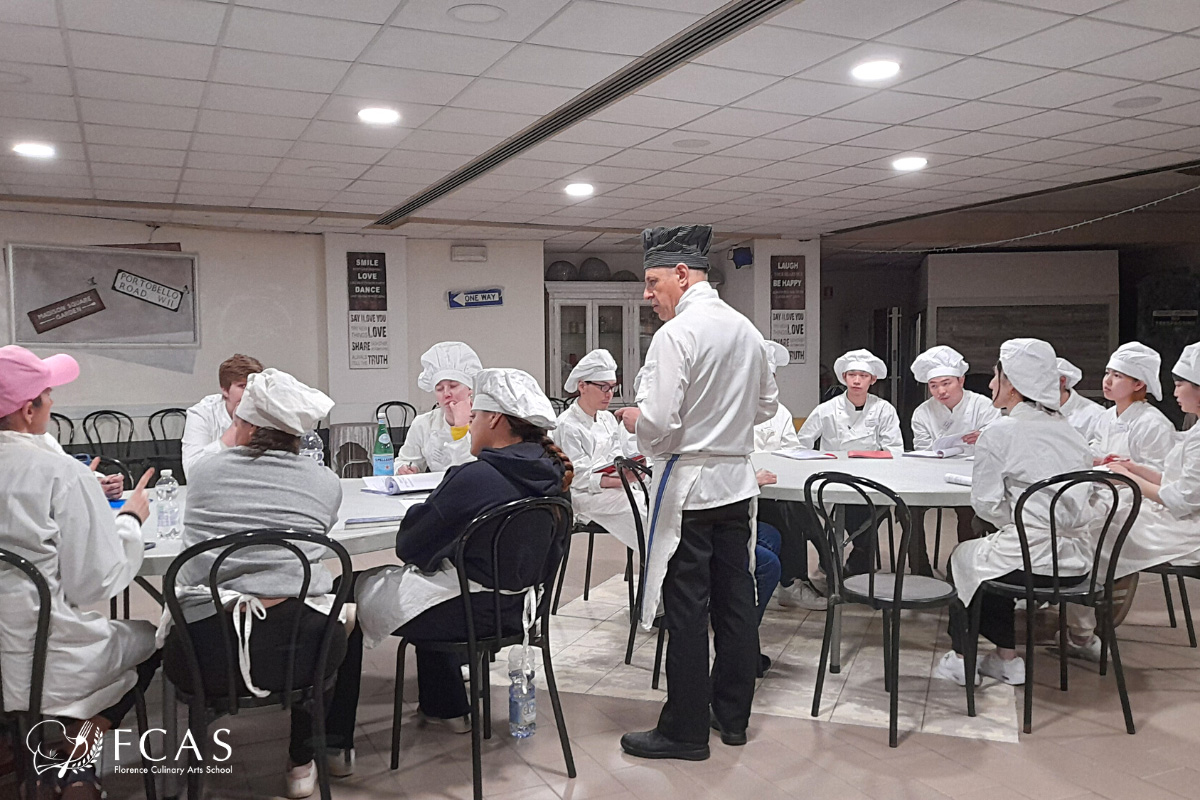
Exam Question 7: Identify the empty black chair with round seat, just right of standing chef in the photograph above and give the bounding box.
[804,473,955,747]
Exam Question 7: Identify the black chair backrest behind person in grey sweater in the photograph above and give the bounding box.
[162,530,353,714]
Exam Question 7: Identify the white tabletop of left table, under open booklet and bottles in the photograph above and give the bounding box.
[138,477,428,576]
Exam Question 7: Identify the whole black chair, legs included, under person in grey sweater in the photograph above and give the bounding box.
[162,530,353,800]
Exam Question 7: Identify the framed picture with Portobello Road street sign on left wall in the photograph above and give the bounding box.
[7,243,200,348]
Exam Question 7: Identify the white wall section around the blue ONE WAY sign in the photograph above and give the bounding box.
[408,239,554,400]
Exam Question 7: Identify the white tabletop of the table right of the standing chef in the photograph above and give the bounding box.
[752,451,972,507]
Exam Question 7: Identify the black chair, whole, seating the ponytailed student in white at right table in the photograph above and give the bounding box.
[964,470,1141,734]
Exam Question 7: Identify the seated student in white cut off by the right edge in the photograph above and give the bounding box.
[1067,343,1200,661]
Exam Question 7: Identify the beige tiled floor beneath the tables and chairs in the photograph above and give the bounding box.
[96,527,1200,800]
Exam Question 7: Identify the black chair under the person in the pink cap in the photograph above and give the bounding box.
[0,548,157,800]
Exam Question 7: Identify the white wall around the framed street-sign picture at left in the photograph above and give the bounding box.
[0,212,326,417]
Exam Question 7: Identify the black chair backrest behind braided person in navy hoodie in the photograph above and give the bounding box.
[455,498,572,651]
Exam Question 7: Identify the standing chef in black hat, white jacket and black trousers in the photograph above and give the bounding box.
[617,225,778,760]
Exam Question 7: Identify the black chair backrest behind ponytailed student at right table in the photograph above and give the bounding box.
[1013,469,1141,603]
